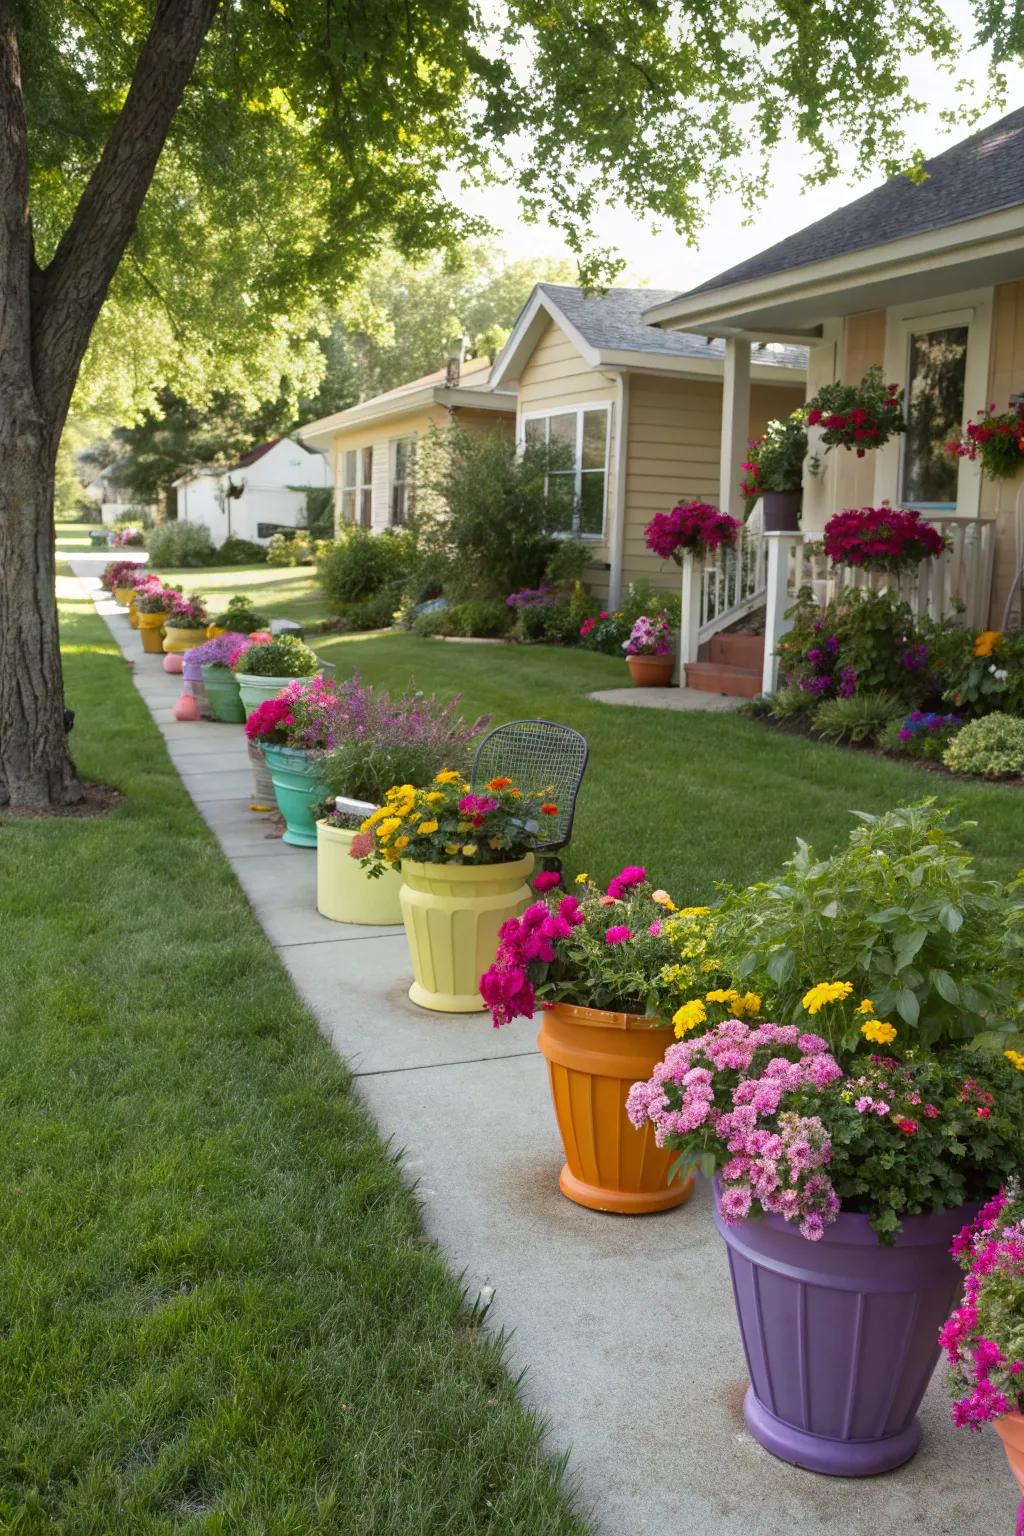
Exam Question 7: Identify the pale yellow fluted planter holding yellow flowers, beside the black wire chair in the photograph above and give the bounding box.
[399,854,533,1014]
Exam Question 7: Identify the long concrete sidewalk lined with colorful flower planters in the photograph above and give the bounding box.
[69,553,1016,1536]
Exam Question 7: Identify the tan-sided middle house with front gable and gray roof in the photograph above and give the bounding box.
[491,283,806,605]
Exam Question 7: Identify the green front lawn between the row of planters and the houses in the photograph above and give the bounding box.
[316,634,1024,902]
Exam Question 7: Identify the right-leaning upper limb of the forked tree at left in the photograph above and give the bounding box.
[33,0,220,436]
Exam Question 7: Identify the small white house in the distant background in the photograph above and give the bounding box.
[173,438,330,547]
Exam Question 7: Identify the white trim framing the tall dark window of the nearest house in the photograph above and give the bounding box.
[875,289,993,518]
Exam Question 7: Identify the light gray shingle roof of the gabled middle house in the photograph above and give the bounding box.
[537,283,808,369]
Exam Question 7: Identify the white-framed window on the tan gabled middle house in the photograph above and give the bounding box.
[524,406,608,539]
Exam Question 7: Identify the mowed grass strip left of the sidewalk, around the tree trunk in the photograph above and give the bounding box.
[0,577,585,1536]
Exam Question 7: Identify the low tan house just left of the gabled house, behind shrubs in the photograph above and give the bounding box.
[298,358,516,531]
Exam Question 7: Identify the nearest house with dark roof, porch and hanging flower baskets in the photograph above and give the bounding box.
[645,109,1024,660]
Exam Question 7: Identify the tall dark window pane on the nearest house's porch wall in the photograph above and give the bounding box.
[900,326,967,511]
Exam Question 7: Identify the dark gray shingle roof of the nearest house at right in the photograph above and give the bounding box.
[672,108,1024,298]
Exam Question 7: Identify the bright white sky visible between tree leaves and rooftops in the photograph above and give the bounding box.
[461,0,1024,292]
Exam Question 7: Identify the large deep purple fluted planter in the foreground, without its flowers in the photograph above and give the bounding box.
[715,1200,978,1478]
